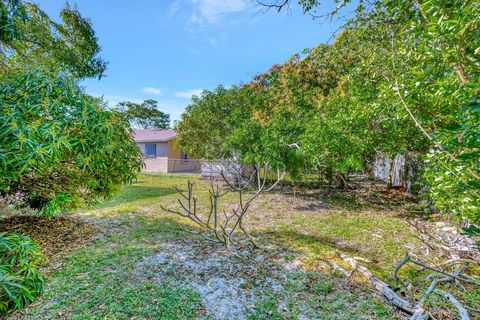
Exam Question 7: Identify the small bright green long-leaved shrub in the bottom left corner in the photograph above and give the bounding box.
[0,232,45,313]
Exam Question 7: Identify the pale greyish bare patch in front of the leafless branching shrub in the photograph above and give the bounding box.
[134,241,312,319]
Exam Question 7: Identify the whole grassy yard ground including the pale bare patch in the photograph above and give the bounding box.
[7,174,480,319]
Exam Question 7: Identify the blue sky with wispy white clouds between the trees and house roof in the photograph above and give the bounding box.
[37,0,340,120]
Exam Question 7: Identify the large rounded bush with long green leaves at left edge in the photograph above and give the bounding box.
[0,72,143,215]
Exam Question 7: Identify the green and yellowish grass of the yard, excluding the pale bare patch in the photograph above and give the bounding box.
[9,173,480,319]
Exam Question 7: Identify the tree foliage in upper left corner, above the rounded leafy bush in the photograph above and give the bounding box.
[0,0,107,79]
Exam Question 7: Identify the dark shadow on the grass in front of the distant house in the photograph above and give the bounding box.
[98,184,176,208]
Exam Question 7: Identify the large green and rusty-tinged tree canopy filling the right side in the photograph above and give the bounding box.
[176,0,480,221]
